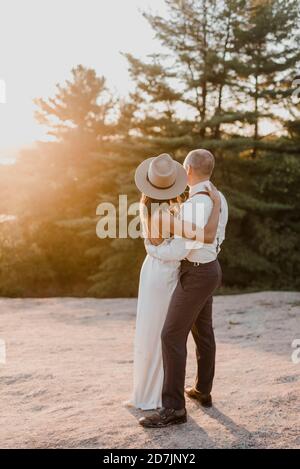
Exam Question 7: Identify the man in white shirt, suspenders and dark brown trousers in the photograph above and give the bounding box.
[140,149,228,428]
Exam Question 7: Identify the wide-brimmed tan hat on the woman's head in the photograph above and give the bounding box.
[135,153,187,200]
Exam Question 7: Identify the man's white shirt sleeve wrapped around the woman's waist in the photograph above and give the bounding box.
[145,238,191,262]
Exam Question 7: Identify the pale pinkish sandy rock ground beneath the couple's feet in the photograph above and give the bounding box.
[0,292,300,449]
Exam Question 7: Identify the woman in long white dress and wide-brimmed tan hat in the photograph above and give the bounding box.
[130,154,219,410]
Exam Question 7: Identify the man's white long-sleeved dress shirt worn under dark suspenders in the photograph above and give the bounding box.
[146,180,228,264]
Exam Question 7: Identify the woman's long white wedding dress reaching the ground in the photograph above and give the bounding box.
[130,207,190,410]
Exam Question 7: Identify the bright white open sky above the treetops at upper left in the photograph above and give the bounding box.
[0,0,165,161]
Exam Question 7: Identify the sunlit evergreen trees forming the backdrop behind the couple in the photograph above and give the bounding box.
[0,0,300,297]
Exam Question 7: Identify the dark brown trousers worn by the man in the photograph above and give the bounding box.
[161,260,222,409]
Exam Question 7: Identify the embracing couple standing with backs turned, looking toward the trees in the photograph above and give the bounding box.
[127,149,228,428]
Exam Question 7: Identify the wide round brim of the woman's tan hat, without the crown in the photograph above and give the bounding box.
[134,156,187,200]
